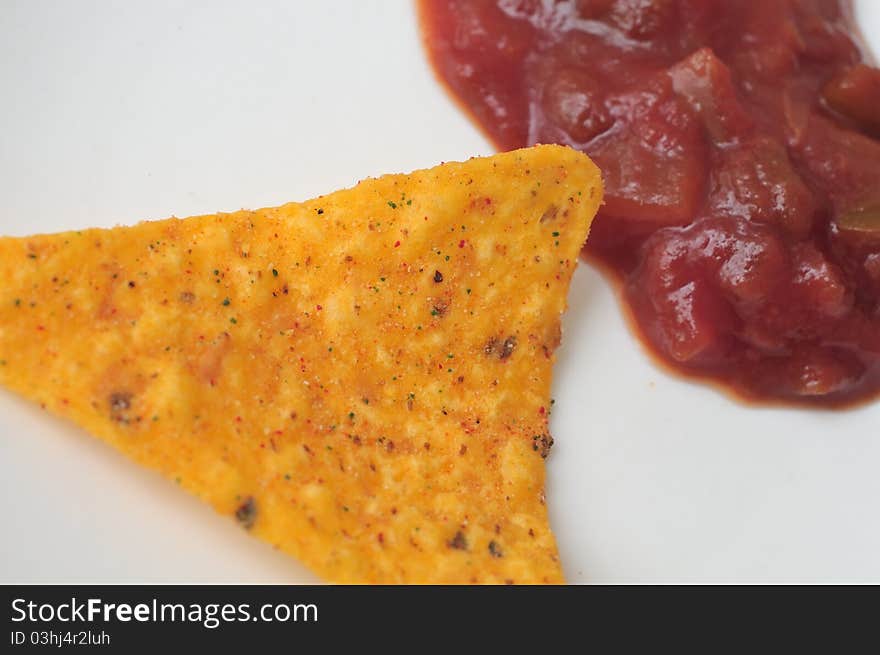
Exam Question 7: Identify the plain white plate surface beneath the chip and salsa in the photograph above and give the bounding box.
[0,0,880,582]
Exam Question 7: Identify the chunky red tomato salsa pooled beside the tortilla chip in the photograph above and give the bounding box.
[420,0,880,405]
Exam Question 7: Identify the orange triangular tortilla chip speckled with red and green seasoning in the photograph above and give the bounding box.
[0,146,601,583]
